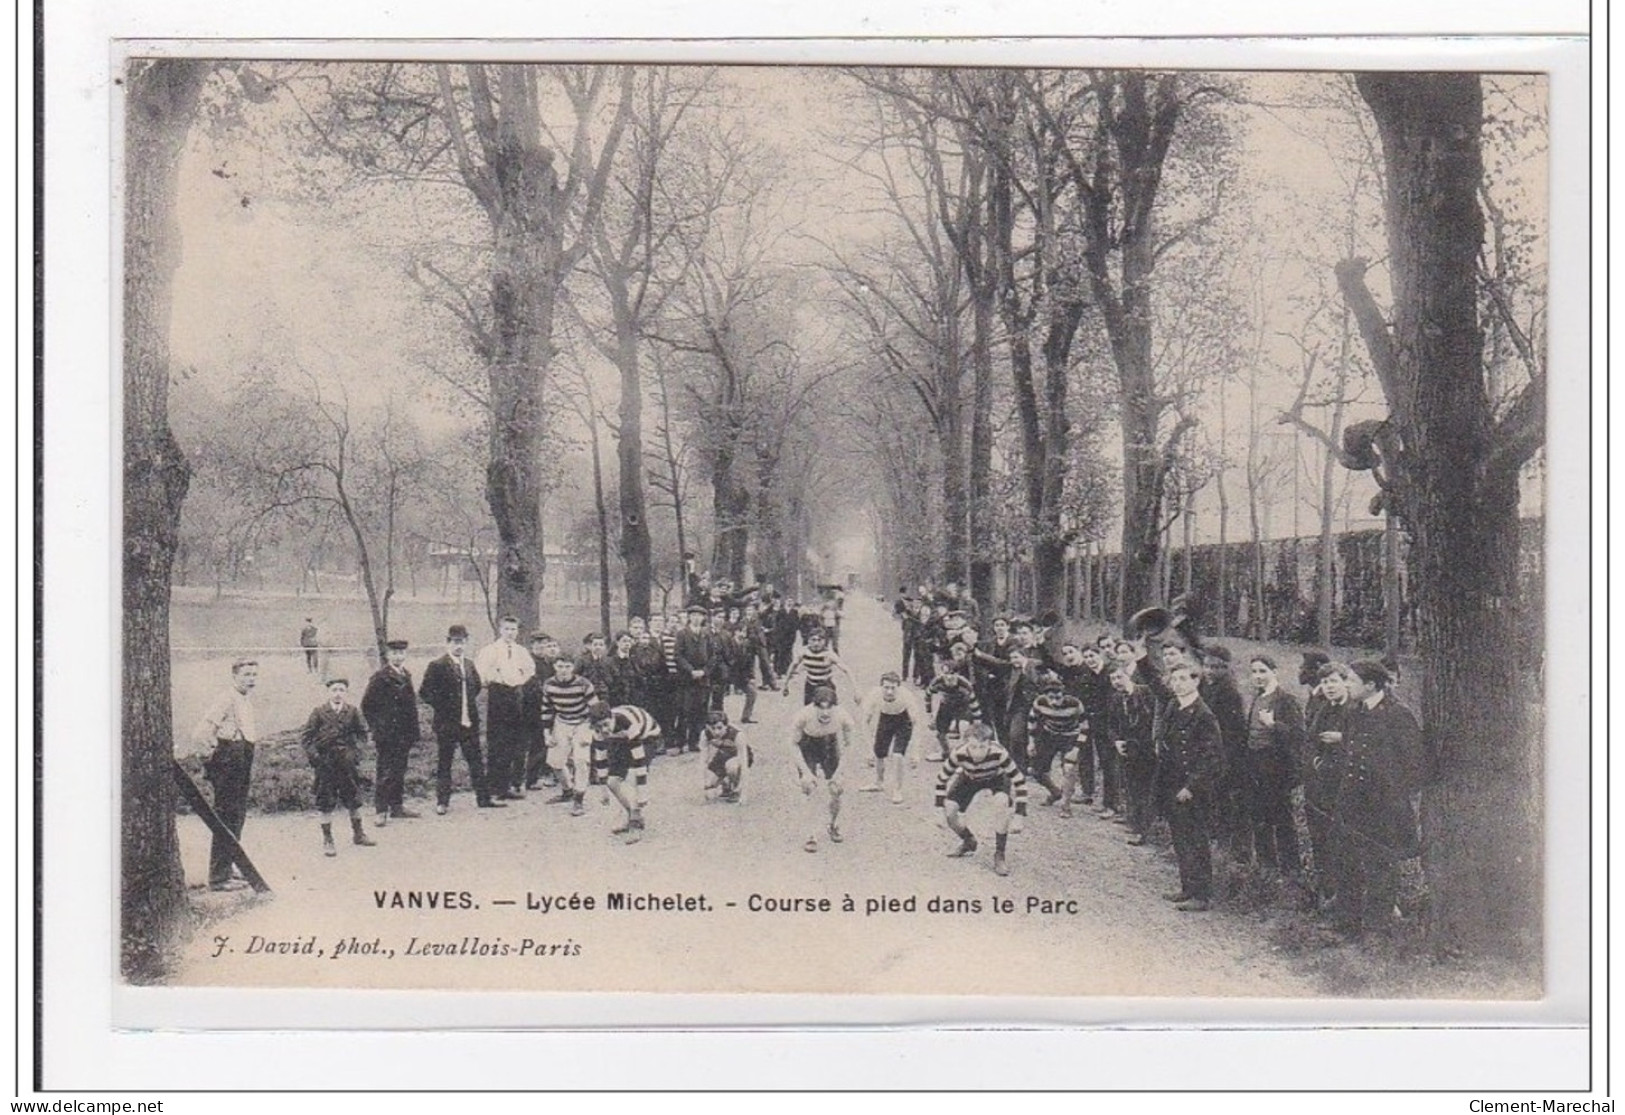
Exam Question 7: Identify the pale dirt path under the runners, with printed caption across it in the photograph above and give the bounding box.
[177,600,1316,996]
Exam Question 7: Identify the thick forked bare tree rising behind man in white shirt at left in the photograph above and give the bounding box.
[295,63,634,626]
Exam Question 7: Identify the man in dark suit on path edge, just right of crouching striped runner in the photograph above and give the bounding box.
[1152,662,1222,912]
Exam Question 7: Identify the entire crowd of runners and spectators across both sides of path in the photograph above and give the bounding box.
[200,580,1422,935]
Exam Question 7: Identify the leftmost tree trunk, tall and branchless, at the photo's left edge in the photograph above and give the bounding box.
[119,59,210,982]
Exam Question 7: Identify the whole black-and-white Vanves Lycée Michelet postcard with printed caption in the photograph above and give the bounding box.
[114,52,1566,1001]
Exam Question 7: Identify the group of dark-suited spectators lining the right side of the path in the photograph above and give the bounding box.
[894,585,1424,936]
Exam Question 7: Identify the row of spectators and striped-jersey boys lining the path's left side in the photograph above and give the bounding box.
[197,588,842,889]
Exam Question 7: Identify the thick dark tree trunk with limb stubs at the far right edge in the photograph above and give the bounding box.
[1339,75,1544,964]
